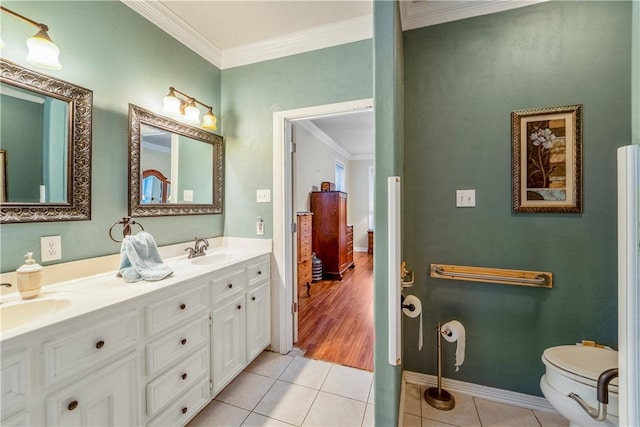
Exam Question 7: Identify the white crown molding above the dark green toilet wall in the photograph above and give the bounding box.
[399,0,549,31]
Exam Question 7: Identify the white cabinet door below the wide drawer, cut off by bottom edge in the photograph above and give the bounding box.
[46,353,140,426]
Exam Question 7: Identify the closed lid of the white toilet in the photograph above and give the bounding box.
[542,345,618,384]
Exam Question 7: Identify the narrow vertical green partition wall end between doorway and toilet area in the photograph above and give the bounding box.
[373,0,404,426]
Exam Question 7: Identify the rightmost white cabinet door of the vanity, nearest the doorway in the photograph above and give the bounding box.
[247,281,271,362]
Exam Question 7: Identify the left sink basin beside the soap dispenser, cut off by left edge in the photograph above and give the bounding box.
[0,293,82,331]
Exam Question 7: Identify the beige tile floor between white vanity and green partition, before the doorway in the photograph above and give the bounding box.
[189,351,373,427]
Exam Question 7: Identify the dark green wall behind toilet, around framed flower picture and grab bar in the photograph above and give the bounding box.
[404,2,631,395]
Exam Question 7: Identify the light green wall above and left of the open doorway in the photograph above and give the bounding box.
[221,40,373,238]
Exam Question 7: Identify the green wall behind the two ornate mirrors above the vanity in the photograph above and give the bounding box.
[0,1,224,271]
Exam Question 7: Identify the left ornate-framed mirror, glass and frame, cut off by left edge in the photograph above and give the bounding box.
[0,59,93,224]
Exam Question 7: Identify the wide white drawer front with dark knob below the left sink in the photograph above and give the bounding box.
[42,311,139,384]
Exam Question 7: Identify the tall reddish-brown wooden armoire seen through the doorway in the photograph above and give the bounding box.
[311,191,353,280]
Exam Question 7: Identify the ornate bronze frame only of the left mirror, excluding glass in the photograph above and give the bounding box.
[0,59,93,224]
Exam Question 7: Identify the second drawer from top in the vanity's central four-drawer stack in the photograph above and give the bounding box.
[146,316,209,376]
